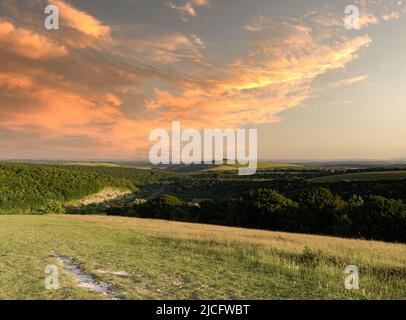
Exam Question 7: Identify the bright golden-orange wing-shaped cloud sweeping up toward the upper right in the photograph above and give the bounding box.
[141,27,371,128]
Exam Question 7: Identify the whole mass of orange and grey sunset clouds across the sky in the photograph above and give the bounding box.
[0,0,398,158]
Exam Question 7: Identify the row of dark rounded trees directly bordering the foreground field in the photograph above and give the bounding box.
[107,188,406,242]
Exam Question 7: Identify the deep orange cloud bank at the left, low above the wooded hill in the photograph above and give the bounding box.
[0,75,141,156]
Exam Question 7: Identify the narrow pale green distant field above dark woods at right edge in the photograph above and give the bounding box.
[310,171,406,182]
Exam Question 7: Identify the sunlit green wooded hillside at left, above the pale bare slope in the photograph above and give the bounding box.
[0,163,136,214]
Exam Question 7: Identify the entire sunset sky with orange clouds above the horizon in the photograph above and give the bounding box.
[0,0,406,160]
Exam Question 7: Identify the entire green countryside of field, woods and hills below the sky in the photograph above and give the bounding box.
[0,163,406,299]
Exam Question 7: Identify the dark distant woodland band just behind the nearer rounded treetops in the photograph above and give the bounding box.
[137,172,406,201]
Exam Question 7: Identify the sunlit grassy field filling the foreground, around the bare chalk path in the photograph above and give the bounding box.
[0,215,406,299]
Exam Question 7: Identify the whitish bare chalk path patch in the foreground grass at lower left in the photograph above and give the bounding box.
[54,255,119,300]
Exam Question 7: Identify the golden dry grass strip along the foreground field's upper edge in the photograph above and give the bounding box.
[72,216,406,267]
